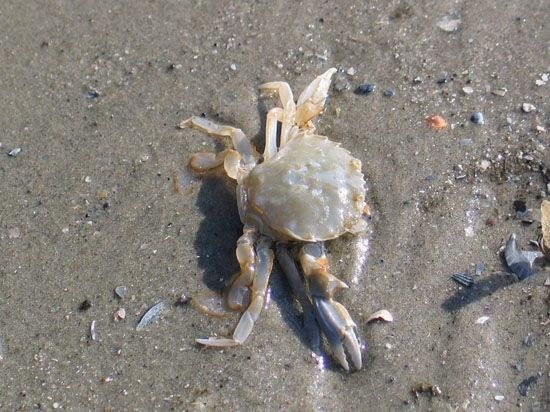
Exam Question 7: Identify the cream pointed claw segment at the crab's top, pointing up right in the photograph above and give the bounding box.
[296,67,337,128]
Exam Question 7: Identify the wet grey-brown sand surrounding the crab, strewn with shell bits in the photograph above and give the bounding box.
[0,0,550,411]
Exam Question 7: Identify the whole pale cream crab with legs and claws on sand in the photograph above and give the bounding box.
[179,68,367,370]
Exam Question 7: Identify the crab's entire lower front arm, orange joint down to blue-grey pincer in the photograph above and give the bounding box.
[299,243,363,370]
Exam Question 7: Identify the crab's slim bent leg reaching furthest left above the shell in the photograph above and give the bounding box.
[179,116,258,167]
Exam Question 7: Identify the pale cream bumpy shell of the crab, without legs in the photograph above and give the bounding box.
[238,133,366,242]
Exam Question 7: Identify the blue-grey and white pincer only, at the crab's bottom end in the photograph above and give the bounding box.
[313,296,363,371]
